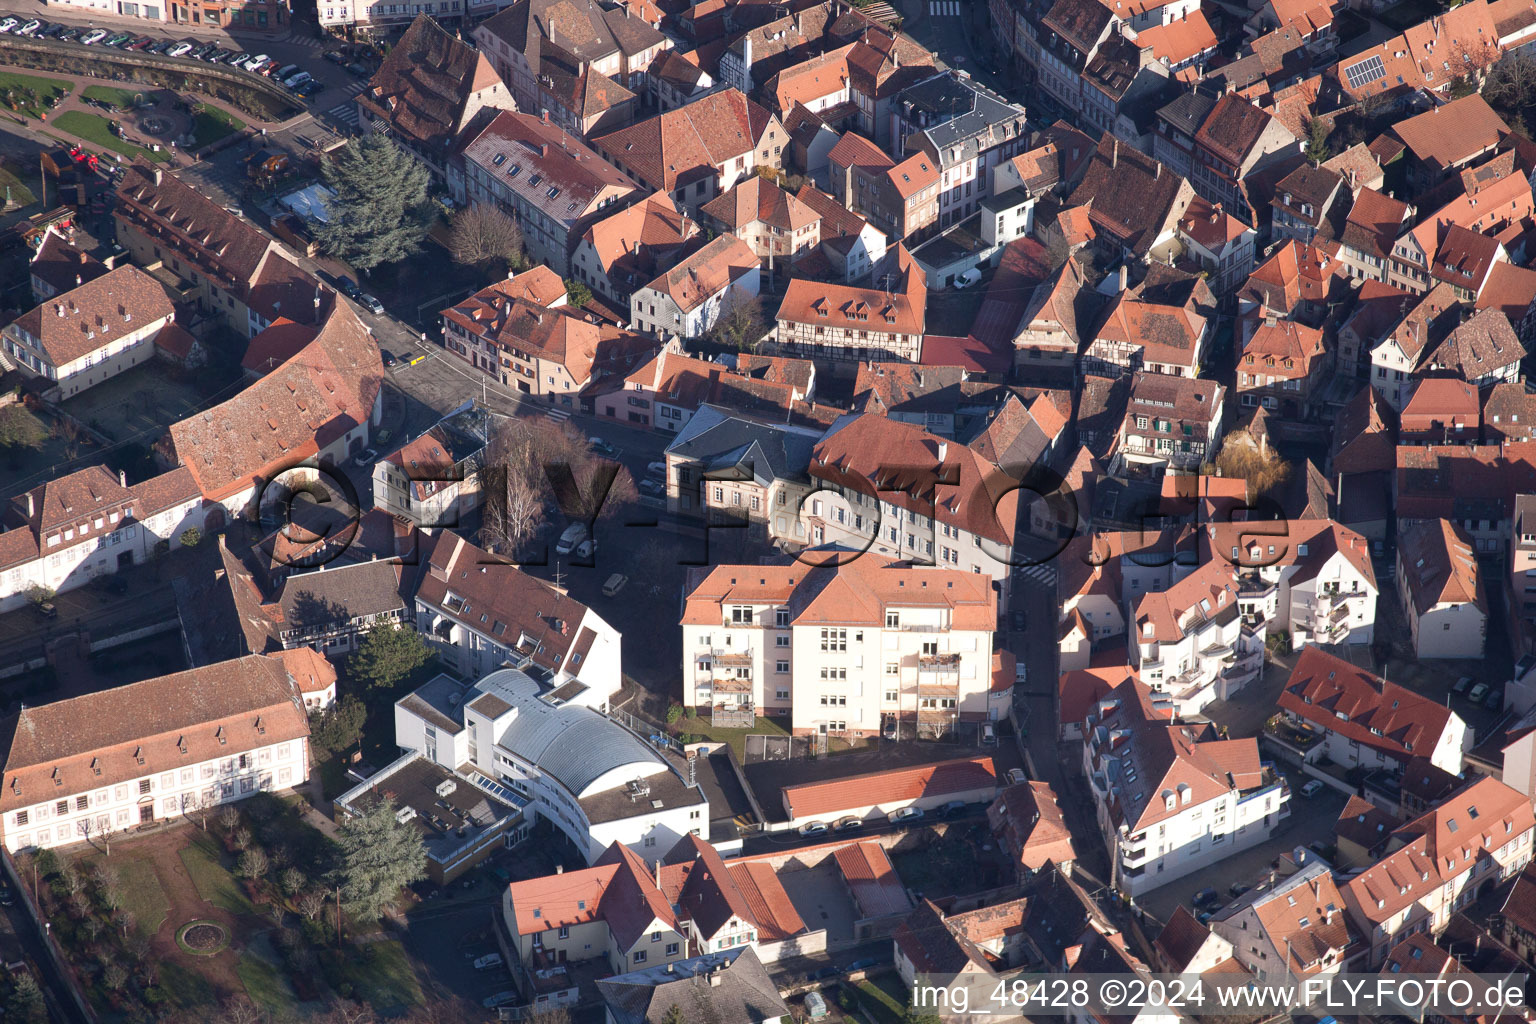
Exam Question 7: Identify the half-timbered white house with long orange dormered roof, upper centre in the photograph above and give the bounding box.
[766,244,928,362]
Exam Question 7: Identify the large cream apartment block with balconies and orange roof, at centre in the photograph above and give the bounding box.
[682,553,1012,737]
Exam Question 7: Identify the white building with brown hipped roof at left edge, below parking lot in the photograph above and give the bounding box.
[0,266,175,401]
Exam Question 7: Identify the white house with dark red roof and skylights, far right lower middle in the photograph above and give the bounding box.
[1275,646,1473,775]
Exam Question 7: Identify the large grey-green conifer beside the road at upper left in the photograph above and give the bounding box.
[318,134,433,273]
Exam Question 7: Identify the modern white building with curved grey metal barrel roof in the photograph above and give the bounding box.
[395,668,710,863]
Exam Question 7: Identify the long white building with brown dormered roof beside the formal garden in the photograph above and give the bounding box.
[0,654,309,854]
